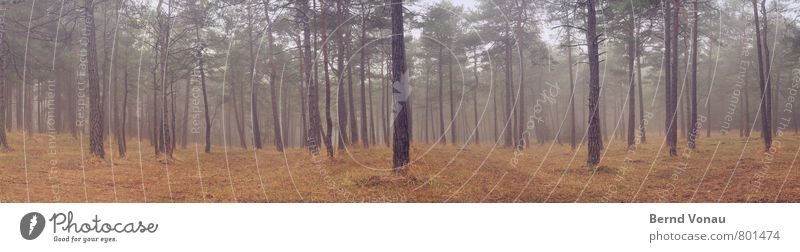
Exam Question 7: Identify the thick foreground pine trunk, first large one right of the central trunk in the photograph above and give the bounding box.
[586,0,603,167]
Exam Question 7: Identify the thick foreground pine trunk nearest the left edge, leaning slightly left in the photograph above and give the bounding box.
[83,0,105,158]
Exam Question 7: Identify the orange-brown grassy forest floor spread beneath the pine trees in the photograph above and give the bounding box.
[0,133,800,203]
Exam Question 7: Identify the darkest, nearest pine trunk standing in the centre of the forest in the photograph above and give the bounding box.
[391,0,411,172]
